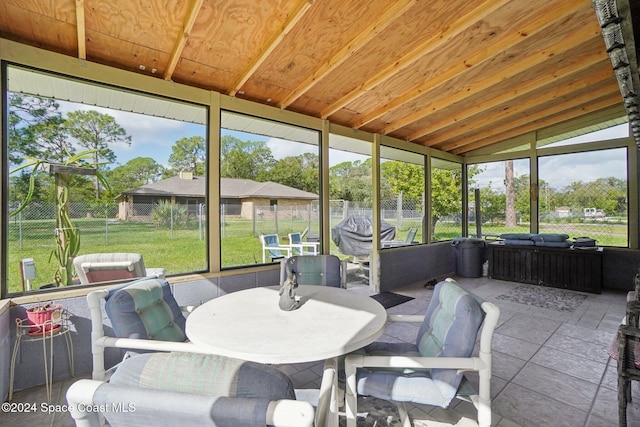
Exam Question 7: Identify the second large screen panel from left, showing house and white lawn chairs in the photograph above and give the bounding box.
[220,111,320,269]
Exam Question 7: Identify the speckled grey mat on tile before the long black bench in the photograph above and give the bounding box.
[496,285,587,313]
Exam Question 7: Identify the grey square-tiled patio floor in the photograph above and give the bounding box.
[5,277,640,427]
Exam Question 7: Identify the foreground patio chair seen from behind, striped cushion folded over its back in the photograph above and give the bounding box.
[67,353,318,427]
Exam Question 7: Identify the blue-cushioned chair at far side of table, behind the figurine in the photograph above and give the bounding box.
[280,255,347,288]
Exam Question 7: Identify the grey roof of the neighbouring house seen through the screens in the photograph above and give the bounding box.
[122,176,318,200]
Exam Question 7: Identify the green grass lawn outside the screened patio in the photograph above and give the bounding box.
[7,218,627,292]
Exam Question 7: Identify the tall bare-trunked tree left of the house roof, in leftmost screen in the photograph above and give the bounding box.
[65,110,131,198]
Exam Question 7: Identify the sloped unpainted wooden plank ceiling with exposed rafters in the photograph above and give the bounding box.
[0,0,622,155]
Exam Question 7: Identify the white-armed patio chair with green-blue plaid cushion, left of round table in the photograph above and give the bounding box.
[87,277,197,380]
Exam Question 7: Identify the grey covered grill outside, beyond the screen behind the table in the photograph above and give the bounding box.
[331,215,396,256]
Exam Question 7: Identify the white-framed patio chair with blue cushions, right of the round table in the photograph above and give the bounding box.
[345,279,500,427]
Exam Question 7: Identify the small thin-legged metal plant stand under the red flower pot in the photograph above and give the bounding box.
[9,309,74,403]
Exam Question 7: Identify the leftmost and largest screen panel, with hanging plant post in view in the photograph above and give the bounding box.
[2,65,208,296]
